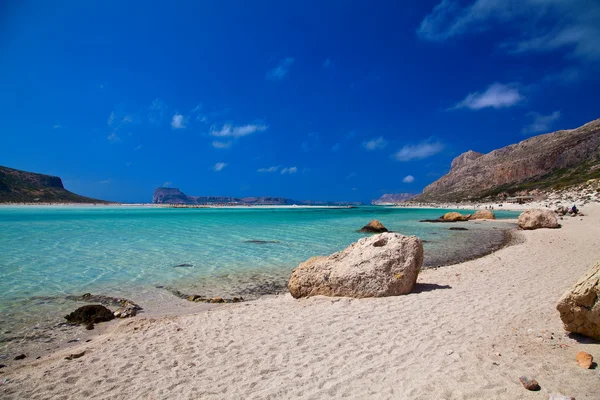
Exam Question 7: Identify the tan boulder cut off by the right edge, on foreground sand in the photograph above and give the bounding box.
[556,262,600,340]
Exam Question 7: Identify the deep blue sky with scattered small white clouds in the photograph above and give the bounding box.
[0,0,600,202]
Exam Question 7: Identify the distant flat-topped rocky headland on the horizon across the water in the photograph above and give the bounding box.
[152,187,362,206]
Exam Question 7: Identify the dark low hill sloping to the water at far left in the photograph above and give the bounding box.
[0,166,107,203]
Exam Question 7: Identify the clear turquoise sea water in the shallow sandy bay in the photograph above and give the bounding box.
[0,206,517,354]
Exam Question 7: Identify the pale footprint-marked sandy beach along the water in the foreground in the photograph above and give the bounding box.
[0,205,600,400]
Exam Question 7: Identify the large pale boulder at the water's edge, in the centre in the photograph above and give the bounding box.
[288,232,423,298]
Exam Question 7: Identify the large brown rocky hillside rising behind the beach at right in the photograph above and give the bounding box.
[414,119,600,202]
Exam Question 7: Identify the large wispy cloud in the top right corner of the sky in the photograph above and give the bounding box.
[417,0,600,60]
